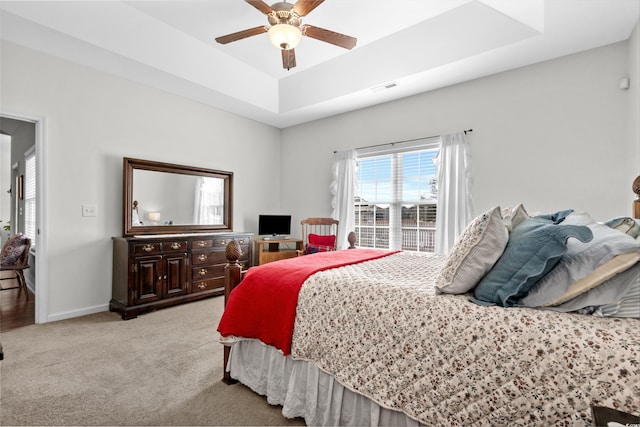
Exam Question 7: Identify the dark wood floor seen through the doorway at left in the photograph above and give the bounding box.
[0,271,36,332]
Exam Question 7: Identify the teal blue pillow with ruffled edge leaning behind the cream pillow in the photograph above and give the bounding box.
[472,215,593,307]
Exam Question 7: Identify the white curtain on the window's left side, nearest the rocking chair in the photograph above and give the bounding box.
[330,150,356,249]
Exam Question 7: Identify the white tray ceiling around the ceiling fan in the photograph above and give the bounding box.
[0,0,640,128]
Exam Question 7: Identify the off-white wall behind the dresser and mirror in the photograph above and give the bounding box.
[0,42,280,319]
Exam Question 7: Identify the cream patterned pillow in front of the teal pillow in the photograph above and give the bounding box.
[436,206,509,294]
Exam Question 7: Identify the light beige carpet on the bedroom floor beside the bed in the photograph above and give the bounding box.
[0,297,304,426]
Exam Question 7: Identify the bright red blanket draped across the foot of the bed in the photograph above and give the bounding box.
[218,249,396,356]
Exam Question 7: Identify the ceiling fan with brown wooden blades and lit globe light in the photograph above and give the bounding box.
[216,0,357,70]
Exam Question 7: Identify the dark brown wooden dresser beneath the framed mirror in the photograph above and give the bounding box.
[109,233,252,320]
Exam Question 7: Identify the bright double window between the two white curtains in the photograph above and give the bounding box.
[354,138,439,252]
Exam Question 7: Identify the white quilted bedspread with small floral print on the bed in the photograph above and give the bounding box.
[292,252,640,426]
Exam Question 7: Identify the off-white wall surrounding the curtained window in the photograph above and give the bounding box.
[282,42,640,231]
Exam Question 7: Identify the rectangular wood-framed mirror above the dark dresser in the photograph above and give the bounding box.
[123,157,233,236]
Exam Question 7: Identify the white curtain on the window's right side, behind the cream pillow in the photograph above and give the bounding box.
[433,132,473,255]
